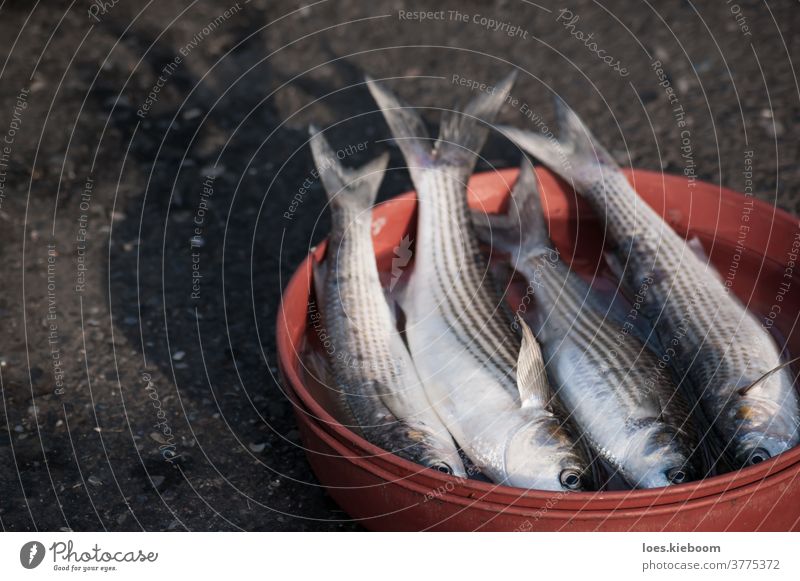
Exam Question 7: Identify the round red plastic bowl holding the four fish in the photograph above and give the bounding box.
[277,168,800,531]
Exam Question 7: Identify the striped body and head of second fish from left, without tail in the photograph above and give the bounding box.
[403,169,586,489]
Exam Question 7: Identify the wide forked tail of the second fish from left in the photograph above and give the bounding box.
[367,71,516,181]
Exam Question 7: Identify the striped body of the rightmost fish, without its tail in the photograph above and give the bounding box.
[586,172,798,464]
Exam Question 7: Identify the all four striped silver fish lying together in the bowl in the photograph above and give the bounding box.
[302,74,800,490]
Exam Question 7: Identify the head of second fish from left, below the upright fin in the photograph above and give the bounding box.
[505,412,589,492]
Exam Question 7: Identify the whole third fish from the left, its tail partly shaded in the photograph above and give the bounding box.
[475,159,698,488]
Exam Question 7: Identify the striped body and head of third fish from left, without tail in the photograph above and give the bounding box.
[518,254,700,487]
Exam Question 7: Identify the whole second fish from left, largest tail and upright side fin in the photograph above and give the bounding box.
[369,76,587,490]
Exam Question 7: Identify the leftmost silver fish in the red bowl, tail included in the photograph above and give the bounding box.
[311,127,466,476]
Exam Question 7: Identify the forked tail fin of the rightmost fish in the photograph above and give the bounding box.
[499,97,619,189]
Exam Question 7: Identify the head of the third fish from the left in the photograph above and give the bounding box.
[622,418,696,488]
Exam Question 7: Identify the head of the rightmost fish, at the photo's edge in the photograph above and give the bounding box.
[719,390,800,467]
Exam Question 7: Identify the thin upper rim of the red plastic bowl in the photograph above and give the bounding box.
[276,167,800,511]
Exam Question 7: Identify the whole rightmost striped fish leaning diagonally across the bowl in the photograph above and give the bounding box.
[502,101,800,468]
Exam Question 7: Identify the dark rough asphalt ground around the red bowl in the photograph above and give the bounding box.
[0,0,800,530]
